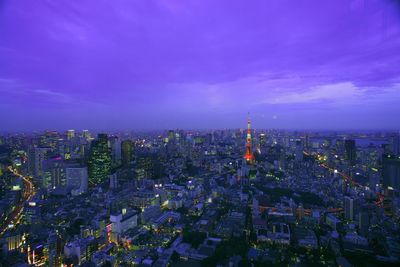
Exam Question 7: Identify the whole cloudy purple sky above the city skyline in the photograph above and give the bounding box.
[0,0,400,130]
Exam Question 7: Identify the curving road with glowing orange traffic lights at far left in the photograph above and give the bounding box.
[0,166,36,237]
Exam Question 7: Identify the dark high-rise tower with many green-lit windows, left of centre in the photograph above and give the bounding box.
[88,134,111,184]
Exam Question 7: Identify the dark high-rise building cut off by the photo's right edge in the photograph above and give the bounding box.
[382,155,400,193]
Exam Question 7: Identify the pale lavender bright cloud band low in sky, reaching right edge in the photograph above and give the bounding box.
[165,73,400,115]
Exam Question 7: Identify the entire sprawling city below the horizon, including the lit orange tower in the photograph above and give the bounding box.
[0,126,400,267]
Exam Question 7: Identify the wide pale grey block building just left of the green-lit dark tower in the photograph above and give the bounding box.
[65,167,88,195]
